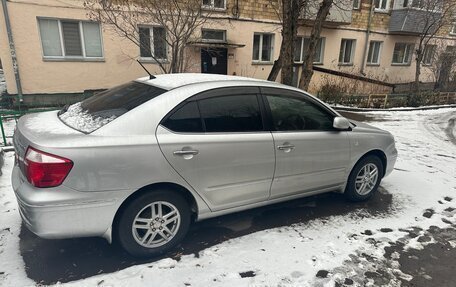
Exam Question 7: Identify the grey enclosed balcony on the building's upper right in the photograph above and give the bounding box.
[389,7,442,35]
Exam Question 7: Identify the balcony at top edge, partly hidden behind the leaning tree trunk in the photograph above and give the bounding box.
[299,1,353,26]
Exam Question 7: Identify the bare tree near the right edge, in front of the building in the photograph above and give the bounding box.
[409,0,456,94]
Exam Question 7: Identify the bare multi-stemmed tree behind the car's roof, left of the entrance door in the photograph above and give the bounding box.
[84,0,209,73]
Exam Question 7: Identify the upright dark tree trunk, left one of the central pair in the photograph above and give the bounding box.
[280,0,299,86]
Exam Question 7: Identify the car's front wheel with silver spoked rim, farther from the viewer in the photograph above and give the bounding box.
[345,155,383,202]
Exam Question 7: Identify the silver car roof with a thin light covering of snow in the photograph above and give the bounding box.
[136,73,268,90]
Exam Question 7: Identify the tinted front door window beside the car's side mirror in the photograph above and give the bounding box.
[266,96,333,131]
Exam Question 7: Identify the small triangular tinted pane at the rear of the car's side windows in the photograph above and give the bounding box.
[163,102,203,133]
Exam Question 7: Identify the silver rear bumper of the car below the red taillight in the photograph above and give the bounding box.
[12,166,130,239]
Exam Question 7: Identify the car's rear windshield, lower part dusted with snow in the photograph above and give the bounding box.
[59,82,166,133]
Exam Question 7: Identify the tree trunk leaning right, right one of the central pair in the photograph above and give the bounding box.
[298,0,334,90]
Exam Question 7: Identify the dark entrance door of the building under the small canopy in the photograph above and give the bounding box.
[201,48,228,75]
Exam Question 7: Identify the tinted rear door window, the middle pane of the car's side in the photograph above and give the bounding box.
[199,95,263,132]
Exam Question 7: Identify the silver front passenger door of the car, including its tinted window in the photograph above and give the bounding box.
[262,88,350,199]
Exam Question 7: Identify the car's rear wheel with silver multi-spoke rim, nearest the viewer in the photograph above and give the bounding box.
[115,190,191,257]
